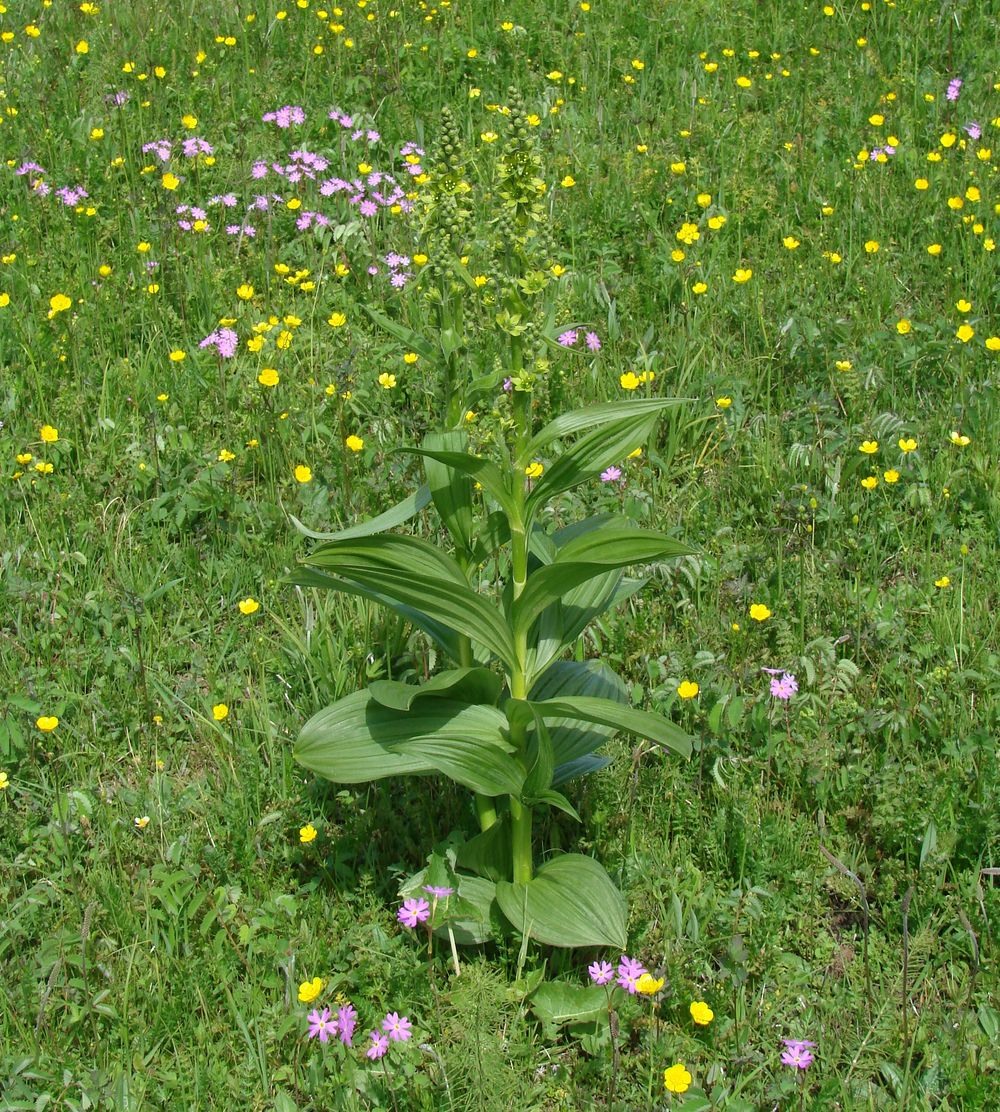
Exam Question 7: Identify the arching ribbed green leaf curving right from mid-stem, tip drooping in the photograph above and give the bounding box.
[514,524,694,634]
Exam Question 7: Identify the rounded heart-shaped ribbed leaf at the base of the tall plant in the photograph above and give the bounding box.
[496,853,628,950]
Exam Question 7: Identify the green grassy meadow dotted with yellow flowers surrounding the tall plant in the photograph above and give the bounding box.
[0,0,1000,1112]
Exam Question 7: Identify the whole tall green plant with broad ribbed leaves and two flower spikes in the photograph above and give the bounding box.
[291,91,691,949]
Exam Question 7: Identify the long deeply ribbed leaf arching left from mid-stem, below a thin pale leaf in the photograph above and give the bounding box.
[306,535,515,668]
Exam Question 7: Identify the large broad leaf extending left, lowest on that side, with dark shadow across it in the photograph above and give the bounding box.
[294,691,505,786]
